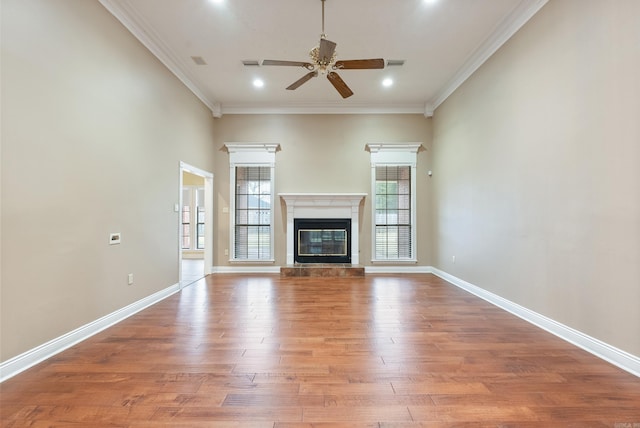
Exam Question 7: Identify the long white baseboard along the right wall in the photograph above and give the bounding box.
[431,267,640,377]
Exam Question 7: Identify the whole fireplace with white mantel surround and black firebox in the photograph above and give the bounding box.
[279,193,367,265]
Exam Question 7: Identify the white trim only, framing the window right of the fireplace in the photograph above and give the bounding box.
[367,143,422,264]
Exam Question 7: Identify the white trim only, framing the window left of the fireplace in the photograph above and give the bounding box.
[225,143,280,263]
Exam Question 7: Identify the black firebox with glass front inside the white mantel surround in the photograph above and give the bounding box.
[293,218,351,263]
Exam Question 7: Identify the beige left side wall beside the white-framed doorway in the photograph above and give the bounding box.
[0,0,216,360]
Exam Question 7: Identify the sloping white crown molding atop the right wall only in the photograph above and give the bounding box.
[425,0,548,115]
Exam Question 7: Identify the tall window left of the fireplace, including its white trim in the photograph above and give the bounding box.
[225,143,279,262]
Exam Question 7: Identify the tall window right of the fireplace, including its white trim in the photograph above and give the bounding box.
[367,143,421,262]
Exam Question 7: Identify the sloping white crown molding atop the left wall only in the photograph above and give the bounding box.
[99,0,222,117]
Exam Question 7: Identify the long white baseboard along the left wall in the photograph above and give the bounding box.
[0,284,180,382]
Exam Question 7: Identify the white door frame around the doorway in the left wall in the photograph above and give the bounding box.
[178,161,213,288]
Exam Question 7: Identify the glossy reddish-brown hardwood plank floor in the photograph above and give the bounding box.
[0,274,640,428]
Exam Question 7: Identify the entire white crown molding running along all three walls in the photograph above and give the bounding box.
[99,0,548,117]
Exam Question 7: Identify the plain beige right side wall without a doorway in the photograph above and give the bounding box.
[433,0,640,355]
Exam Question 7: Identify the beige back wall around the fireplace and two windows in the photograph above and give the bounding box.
[215,114,431,266]
